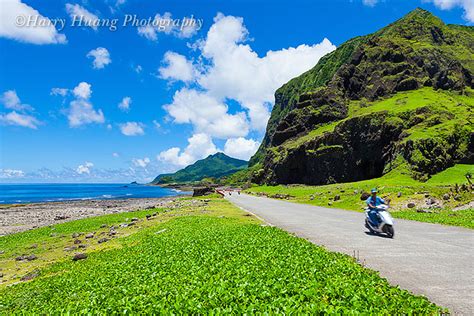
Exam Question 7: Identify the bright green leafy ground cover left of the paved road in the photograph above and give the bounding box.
[0,198,442,314]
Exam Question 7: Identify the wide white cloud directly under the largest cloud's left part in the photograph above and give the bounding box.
[164,88,249,138]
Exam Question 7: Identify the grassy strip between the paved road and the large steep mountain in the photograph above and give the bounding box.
[247,164,474,228]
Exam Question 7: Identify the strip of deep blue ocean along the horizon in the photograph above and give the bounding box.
[0,183,187,204]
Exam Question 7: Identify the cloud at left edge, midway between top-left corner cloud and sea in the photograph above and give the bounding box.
[0,90,40,129]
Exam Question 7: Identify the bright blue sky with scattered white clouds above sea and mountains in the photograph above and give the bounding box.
[0,0,474,182]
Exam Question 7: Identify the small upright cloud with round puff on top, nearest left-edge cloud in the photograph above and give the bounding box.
[67,82,105,127]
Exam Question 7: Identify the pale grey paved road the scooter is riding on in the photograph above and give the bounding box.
[226,194,474,315]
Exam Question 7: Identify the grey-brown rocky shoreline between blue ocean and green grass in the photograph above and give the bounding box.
[0,197,176,236]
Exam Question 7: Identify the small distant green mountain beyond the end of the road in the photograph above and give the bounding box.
[152,153,248,184]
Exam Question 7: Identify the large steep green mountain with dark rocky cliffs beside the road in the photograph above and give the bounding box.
[250,9,474,184]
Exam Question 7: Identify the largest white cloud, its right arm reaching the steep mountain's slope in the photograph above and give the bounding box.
[194,14,336,131]
